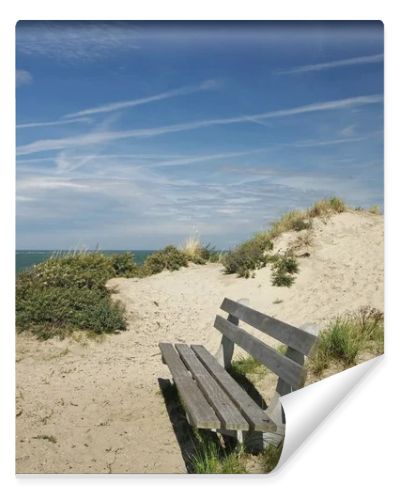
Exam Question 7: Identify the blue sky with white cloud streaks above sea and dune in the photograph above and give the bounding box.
[16,22,383,249]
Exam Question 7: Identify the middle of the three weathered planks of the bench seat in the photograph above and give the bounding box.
[175,344,249,431]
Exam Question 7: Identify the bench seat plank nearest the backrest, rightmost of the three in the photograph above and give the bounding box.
[191,345,276,431]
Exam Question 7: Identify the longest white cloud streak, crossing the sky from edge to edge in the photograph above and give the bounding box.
[17,95,383,155]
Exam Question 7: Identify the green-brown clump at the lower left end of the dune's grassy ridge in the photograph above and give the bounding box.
[222,233,273,278]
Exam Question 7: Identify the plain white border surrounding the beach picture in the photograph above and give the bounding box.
[0,0,400,500]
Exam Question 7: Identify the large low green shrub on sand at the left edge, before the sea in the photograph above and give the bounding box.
[16,253,130,339]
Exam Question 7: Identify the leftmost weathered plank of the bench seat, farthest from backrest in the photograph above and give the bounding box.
[159,342,221,429]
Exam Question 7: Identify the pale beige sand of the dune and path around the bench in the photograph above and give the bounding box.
[16,213,383,473]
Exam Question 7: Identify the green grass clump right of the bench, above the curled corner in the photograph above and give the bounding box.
[309,307,384,375]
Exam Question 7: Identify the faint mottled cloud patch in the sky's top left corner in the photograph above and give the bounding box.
[16,21,138,62]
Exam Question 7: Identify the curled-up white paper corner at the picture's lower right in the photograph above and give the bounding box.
[273,355,383,472]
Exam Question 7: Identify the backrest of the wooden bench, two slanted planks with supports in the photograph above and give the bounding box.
[214,298,317,396]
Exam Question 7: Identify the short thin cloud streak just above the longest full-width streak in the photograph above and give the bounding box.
[65,80,219,118]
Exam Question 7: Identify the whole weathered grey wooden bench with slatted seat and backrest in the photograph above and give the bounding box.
[159,298,317,449]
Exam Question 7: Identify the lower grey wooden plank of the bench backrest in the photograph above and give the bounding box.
[214,315,306,389]
